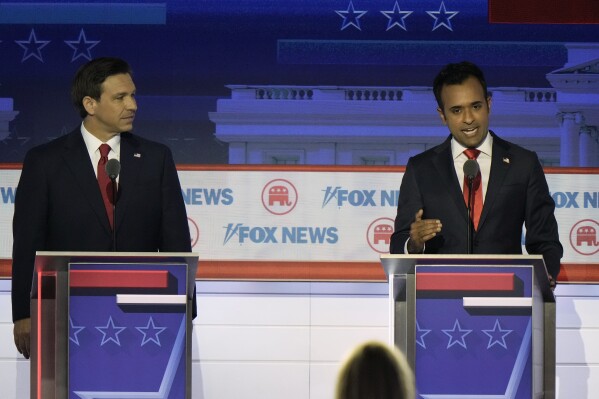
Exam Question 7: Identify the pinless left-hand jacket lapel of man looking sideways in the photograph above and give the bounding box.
[62,129,111,232]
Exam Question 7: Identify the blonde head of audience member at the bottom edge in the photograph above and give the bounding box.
[335,341,415,399]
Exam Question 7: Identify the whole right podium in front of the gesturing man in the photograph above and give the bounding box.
[381,255,555,399]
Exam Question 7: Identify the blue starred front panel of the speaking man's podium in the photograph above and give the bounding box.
[415,266,533,399]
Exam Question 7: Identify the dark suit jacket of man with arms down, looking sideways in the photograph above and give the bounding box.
[12,128,195,321]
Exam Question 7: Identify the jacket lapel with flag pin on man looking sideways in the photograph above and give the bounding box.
[116,133,143,228]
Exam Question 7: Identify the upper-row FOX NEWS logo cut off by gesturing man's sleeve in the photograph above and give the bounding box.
[322,186,399,208]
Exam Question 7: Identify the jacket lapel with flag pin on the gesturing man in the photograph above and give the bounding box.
[478,132,512,231]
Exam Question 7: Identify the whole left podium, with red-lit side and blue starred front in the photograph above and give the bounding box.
[31,252,198,399]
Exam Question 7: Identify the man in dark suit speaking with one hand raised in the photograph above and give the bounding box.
[390,62,563,285]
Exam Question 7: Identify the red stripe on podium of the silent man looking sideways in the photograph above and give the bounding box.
[69,270,168,288]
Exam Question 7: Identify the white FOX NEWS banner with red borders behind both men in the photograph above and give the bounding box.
[0,166,599,281]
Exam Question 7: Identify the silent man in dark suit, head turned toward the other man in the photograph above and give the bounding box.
[12,58,195,358]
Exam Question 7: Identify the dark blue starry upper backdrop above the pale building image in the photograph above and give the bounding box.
[0,0,599,164]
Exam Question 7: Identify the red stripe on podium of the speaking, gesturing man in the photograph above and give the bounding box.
[416,273,514,291]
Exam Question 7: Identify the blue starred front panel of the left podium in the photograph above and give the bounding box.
[69,264,187,399]
